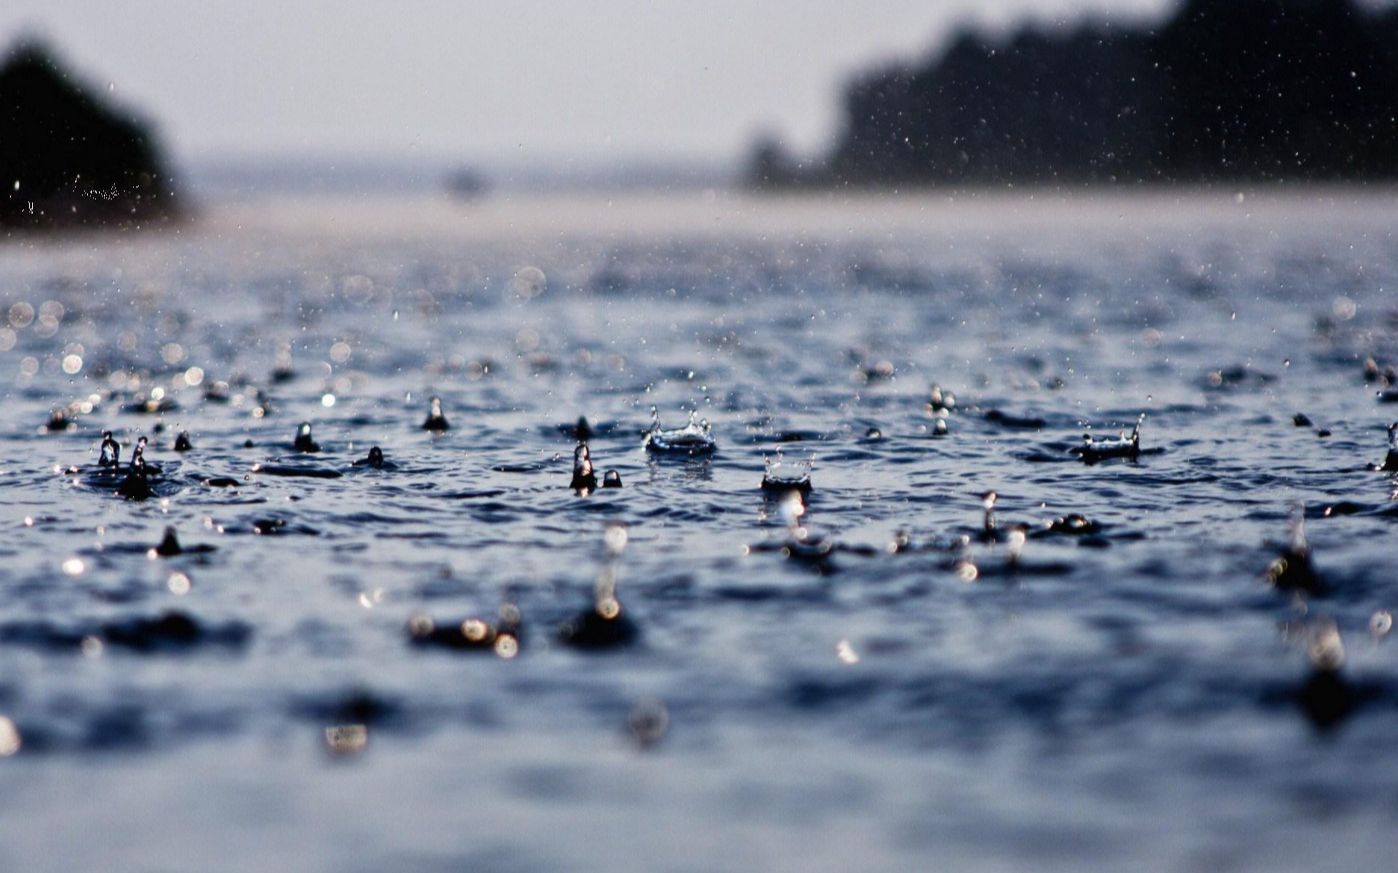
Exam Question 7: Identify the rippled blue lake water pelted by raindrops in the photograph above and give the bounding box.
[0,192,1398,872]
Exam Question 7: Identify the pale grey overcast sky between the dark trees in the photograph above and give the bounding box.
[0,0,1172,161]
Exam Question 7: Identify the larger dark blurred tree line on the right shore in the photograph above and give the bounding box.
[748,0,1398,187]
